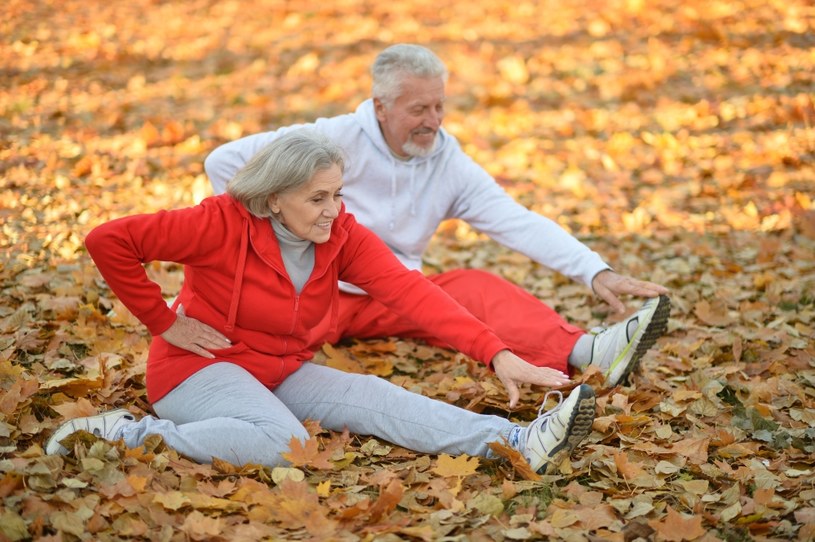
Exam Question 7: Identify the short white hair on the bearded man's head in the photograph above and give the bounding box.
[371,43,448,107]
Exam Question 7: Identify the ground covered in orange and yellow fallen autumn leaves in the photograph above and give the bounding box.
[0,0,815,541]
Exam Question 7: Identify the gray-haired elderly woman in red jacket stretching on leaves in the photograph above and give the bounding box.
[46,130,594,472]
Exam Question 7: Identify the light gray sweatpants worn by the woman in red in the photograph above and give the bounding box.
[121,362,517,467]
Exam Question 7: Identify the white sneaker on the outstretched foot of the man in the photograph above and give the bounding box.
[590,295,671,387]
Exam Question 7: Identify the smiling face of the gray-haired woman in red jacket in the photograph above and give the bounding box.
[269,164,342,243]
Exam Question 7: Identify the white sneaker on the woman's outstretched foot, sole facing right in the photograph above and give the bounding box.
[521,384,594,474]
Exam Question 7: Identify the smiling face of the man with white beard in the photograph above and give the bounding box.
[374,76,444,158]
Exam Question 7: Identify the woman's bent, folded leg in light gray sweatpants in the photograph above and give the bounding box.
[122,362,308,466]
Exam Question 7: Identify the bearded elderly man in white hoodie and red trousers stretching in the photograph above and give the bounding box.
[205,44,670,400]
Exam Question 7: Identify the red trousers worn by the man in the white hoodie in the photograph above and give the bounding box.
[332,269,586,372]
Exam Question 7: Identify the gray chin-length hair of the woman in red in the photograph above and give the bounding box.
[226,128,345,218]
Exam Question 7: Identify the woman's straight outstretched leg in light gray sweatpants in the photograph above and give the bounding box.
[275,363,516,457]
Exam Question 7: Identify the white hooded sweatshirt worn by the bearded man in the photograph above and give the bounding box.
[204,99,609,293]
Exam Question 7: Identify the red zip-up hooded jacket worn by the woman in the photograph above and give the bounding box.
[85,195,508,402]
